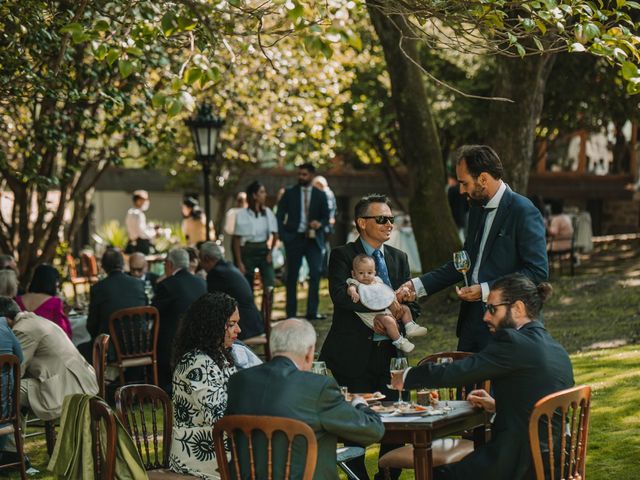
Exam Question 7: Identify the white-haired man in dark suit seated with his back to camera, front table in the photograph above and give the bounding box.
[226,318,384,480]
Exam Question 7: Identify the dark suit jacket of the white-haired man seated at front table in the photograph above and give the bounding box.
[226,357,384,480]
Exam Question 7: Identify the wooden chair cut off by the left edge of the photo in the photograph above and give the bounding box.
[0,355,27,480]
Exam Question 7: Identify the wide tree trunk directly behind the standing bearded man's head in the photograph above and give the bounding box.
[485,55,556,195]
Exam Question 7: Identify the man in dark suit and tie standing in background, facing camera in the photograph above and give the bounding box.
[276,163,329,320]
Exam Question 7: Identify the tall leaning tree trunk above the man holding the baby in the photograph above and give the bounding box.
[367,0,460,271]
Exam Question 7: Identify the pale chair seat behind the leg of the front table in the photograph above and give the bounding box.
[378,438,473,469]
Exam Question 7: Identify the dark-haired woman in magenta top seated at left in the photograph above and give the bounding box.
[16,263,72,338]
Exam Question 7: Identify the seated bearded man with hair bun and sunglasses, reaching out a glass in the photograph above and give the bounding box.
[392,273,573,480]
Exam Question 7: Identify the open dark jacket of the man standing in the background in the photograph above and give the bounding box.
[276,185,329,250]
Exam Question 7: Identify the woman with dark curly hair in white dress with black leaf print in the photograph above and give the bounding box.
[169,292,240,479]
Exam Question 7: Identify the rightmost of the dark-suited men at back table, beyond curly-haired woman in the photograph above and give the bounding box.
[200,242,264,340]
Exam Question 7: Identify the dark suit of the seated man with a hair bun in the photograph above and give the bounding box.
[405,321,573,480]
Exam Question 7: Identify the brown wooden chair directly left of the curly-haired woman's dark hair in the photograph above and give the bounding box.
[109,307,160,385]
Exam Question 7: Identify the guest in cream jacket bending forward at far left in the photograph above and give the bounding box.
[0,297,98,420]
